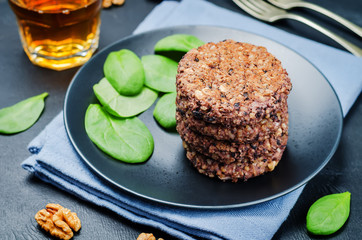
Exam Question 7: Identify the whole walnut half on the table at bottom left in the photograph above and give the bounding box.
[35,203,81,240]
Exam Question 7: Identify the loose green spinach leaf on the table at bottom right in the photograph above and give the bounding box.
[307,192,351,235]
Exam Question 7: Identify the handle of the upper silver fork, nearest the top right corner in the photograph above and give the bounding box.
[288,1,362,37]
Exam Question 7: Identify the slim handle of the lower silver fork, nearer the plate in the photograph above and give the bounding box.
[287,13,362,57]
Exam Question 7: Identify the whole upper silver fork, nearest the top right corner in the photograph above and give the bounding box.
[268,0,362,37]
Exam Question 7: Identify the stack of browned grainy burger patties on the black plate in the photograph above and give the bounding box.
[176,40,292,182]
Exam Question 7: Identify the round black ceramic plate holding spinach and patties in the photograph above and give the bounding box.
[64,26,343,208]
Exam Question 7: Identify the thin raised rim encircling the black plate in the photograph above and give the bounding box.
[63,25,343,209]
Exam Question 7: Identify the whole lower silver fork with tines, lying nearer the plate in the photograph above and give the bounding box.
[233,0,362,57]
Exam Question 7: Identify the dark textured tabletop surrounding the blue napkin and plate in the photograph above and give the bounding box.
[0,0,362,240]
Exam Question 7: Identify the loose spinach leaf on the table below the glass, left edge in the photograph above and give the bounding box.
[0,92,48,134]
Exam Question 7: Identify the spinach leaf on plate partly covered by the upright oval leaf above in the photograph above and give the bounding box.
[93,78,158,117]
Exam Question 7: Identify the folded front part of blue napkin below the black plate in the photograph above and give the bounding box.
[22,113,302,240]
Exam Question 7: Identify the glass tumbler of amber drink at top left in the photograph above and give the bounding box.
[9,0,102,70]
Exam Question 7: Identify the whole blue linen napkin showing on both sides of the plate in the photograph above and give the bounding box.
[22,0,362,239]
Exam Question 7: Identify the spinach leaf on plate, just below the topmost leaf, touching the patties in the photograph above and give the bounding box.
[141,55,178,92]
